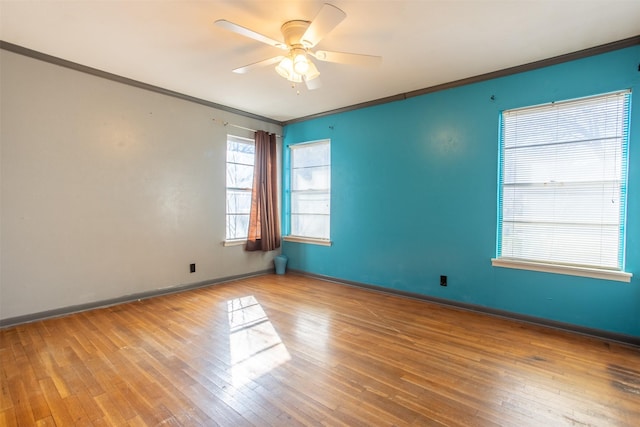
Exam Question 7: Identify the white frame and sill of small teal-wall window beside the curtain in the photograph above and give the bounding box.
[283,139,331,246]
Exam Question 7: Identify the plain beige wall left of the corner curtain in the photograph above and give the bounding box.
[0,50,281,319]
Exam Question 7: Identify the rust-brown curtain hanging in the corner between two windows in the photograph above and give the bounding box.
[245,130,280,252]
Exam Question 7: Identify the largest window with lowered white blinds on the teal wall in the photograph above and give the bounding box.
[493,91,631,281]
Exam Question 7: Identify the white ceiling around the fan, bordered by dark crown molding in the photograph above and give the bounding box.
[0,0,640,121]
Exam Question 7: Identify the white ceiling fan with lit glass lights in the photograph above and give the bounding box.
[215,3,382,90]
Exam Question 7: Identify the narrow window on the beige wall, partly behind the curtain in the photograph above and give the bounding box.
[225,135,255,240]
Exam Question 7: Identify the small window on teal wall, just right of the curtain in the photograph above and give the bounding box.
[288,140,331,243]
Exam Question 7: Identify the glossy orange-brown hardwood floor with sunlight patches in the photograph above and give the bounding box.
[0,274,640,426]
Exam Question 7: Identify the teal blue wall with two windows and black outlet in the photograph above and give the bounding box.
[283,46,640,336]
